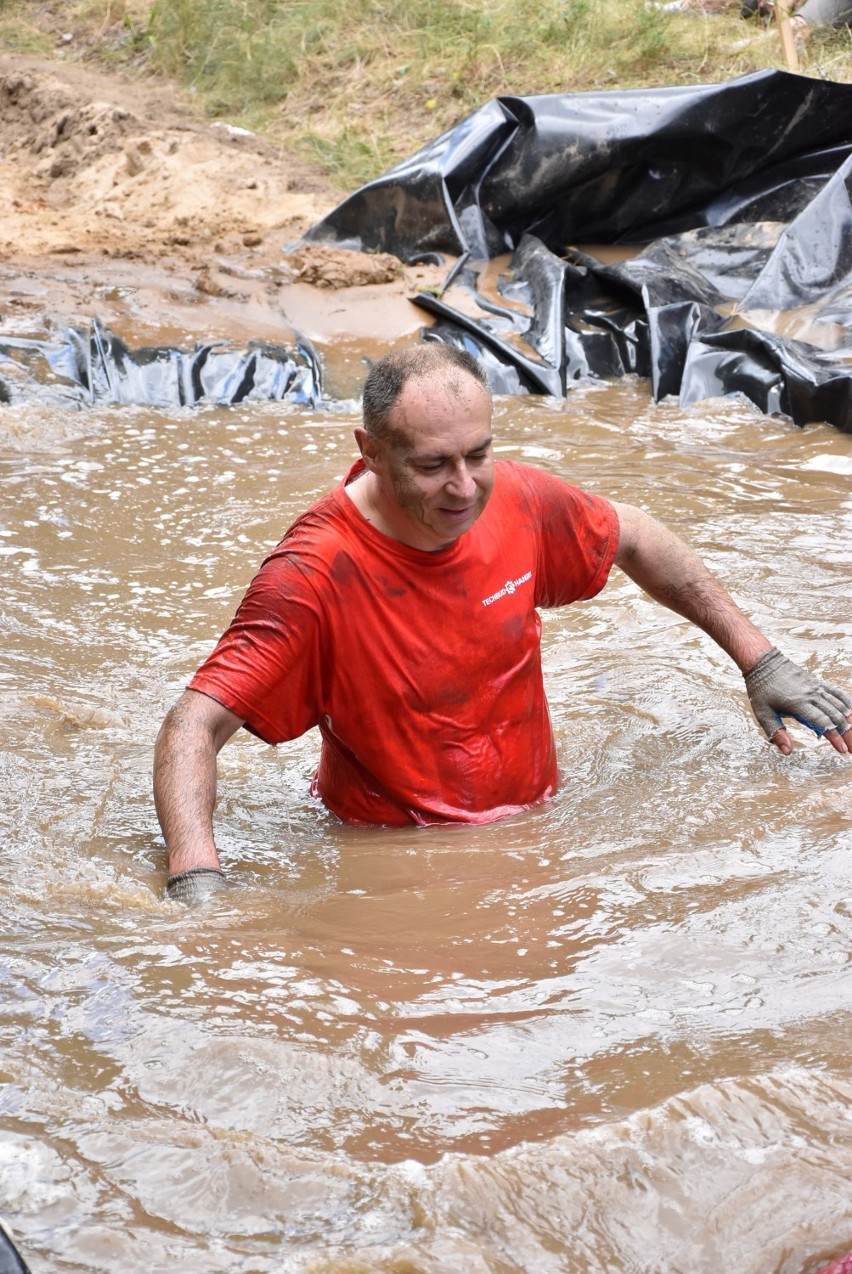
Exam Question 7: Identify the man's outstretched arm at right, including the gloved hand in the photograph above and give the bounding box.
[615,503,852,755]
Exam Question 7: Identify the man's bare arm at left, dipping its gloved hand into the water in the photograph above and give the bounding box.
[154,691,243,901]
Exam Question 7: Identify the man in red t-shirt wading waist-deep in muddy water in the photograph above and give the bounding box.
[154,343,852,902]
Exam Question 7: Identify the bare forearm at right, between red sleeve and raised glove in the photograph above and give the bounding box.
[615,505,772,673]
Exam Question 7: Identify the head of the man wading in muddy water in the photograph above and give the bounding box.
[355,341,494,550]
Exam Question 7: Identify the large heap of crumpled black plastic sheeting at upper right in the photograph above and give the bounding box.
[306,71,852,432]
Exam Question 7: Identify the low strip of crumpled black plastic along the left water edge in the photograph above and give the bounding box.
[0,319,322,408]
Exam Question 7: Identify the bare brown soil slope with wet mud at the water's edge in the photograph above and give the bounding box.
[0,57,446,372]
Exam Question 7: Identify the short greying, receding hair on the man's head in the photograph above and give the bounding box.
[362,341,492,442]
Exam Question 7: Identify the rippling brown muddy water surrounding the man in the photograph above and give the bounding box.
[0,381,852,1274]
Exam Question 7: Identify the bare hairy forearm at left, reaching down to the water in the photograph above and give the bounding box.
[154,699,229,875]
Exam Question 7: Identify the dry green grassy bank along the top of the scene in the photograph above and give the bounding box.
[0,0,852,189]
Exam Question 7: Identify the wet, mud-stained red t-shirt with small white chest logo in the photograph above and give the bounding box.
[190,460,618,824]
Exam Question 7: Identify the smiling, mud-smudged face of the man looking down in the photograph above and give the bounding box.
[362,371,494,550]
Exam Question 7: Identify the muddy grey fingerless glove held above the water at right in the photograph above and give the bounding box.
[745,646,852,739]
